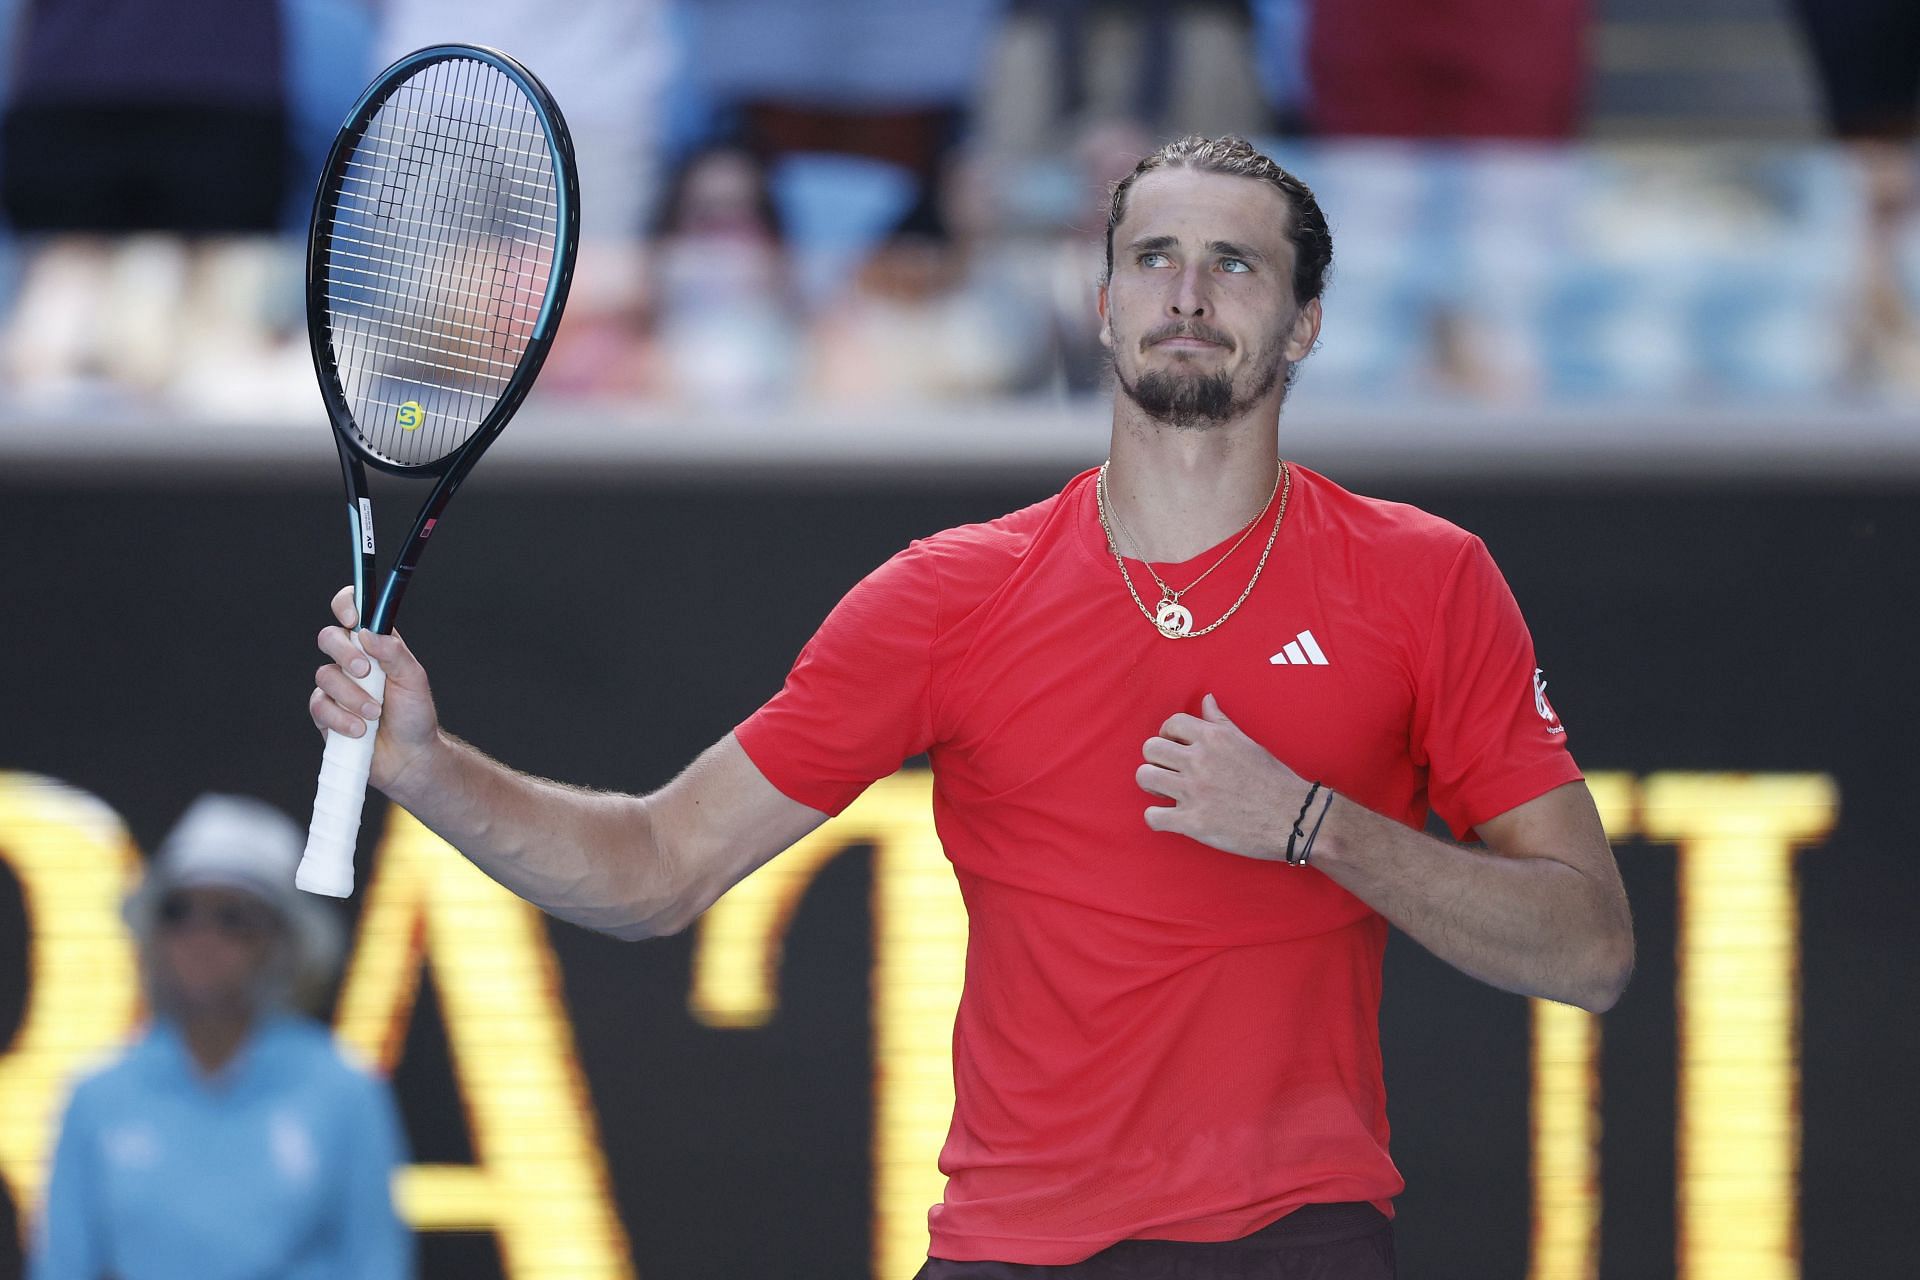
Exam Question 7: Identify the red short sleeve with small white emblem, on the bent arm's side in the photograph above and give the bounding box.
[1413,537,1580,837]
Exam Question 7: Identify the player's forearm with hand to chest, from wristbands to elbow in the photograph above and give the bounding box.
[1311,796,1632,1011]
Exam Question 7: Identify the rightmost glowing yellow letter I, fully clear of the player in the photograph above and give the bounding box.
[1642,773,1839,1280]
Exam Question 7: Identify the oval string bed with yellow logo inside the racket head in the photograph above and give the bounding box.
[324,59,561,466]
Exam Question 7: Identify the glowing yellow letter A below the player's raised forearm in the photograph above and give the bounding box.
[336,808,634,1280]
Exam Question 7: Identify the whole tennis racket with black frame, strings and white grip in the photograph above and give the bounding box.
[294,44,580,898]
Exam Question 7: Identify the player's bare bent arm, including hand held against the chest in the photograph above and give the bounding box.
[1135,695,1634,1013]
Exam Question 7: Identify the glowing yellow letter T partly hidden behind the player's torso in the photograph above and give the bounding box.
[689,771,966,1276]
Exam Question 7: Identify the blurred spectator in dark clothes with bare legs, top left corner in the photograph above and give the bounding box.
[0,0,292,399]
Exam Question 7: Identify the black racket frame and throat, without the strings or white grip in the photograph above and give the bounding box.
[307,44,580,635]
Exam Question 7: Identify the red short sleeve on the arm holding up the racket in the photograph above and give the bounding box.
[733,543,941,814]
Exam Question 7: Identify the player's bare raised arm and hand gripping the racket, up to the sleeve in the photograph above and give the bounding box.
[307,587,826,938]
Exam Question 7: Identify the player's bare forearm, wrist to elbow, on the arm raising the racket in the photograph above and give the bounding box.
[388,731,691,938]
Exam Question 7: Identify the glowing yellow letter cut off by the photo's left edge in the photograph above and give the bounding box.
[0,773,140,1226]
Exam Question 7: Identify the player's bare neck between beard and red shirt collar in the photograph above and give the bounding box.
[1106,415,1279,564]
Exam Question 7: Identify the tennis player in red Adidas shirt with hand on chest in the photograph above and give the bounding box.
[311,138,1632,1280]
